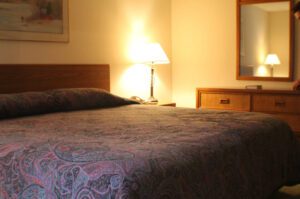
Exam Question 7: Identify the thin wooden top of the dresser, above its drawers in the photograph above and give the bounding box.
[197,88,300,95]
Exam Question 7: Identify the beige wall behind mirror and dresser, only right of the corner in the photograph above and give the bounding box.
[172,0,300,107]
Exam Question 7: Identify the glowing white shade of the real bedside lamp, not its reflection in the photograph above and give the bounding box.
[141,43,170,64]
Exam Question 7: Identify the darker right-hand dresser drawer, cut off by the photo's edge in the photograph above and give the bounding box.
[252,94,300,113]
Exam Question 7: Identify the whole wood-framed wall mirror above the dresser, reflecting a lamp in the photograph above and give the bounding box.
[237,0,294,81]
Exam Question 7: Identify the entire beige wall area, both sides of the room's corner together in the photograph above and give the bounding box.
[0,0,300,107]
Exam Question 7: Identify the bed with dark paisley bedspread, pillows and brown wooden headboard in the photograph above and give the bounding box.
[0,65,300,199]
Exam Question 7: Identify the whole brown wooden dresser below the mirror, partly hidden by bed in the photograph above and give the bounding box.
[196,88,300,138]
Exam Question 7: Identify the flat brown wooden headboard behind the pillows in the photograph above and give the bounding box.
[0,64,110,93]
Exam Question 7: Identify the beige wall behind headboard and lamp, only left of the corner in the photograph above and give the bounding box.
[0,0,171,102]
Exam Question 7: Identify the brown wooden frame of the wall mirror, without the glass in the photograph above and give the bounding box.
[236,0,295,82]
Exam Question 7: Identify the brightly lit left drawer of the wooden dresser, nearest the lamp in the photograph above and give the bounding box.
[200,93,250,111]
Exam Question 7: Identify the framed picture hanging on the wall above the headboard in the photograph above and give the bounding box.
[0,0,69,42]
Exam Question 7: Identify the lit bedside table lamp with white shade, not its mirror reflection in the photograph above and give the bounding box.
[142,43,170,104]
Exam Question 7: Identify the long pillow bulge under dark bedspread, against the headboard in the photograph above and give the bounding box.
[0,88,136,119]
